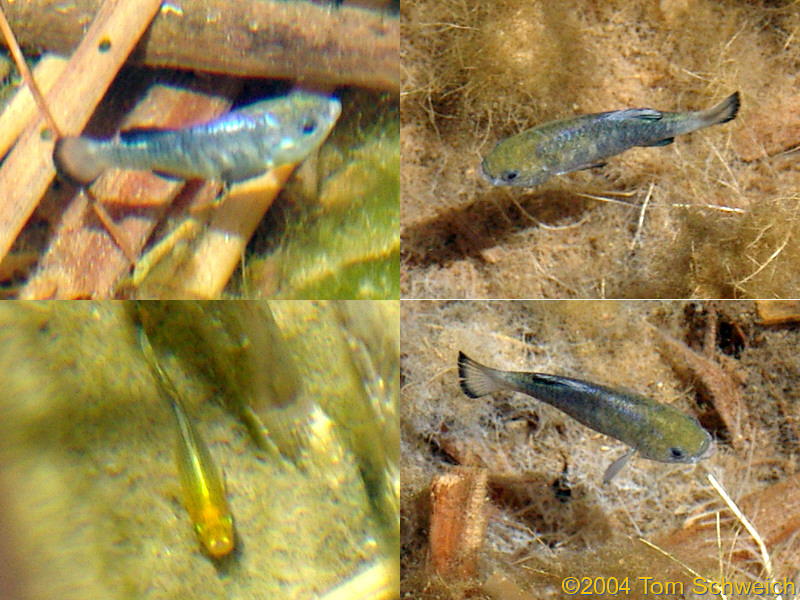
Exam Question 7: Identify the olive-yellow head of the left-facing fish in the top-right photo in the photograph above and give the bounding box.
[480,134,553,188]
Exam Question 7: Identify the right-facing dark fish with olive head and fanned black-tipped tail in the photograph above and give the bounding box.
[458,352,714,483]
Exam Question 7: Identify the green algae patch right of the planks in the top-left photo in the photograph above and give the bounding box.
[240,94,400,299]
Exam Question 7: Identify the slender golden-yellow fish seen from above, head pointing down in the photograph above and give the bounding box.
[139,329,235,558]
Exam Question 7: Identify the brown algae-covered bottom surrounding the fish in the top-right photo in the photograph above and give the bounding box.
[401,0,800,298]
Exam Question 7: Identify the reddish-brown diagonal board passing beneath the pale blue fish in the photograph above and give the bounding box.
[20,81,238,298]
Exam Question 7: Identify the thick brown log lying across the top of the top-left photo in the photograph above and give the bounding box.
[0,0,400,91]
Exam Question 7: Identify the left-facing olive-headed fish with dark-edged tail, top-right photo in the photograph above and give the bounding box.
[480,92,739,188]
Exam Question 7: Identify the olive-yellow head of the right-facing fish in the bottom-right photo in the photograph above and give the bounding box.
[636,405,715,463]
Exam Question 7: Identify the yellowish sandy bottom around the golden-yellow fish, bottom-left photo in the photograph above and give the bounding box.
[0,302,397,600]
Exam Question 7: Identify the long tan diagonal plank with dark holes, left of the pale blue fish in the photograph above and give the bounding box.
[0,0,161,268]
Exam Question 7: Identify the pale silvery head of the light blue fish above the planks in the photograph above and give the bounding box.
[270,91,342,164]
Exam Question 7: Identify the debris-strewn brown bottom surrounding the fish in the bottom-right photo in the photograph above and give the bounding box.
[400,301,800,600]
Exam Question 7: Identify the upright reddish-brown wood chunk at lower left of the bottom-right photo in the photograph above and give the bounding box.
[428,467,489,579]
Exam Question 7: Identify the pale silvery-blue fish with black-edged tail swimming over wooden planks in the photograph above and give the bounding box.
[53,91,342,185]
